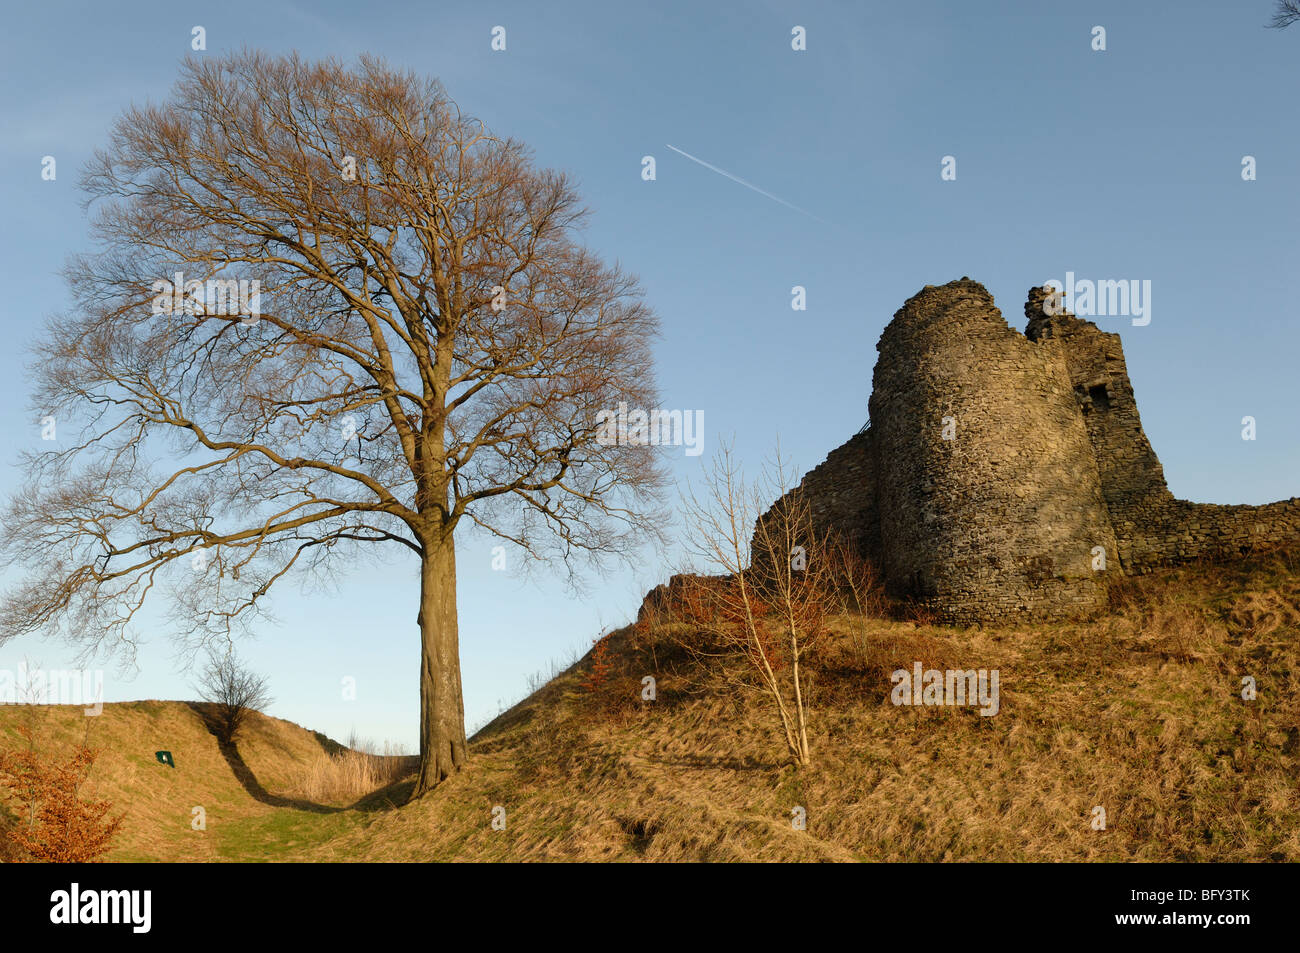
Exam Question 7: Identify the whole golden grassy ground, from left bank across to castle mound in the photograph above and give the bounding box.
[0,554,1300,862]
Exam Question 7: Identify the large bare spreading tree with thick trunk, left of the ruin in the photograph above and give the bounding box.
[0,53,663,794]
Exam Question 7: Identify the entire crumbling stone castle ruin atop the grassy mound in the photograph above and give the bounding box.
[764,278,1300,623]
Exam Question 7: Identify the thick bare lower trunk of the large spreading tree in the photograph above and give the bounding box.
[412,532,465,797]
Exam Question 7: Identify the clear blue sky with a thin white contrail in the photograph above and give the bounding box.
[0,0,1300,748]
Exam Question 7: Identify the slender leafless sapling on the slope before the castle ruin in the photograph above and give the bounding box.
[684,447,841,766]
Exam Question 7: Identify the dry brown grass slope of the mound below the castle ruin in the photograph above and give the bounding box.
[369,543,1300,861]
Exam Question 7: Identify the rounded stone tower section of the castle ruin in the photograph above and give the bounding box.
[870,280,1114,621]
